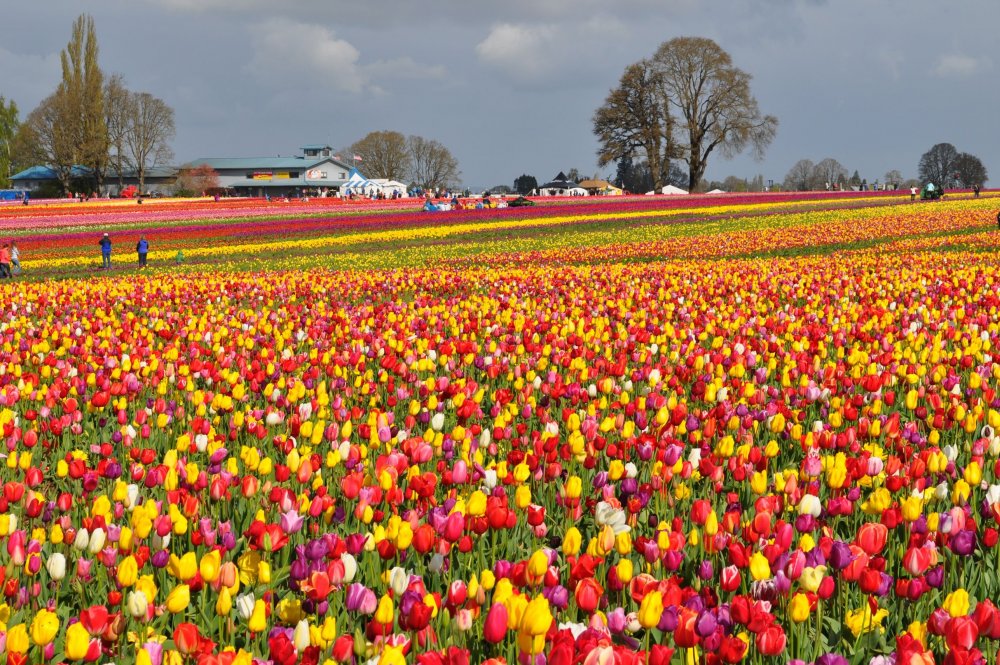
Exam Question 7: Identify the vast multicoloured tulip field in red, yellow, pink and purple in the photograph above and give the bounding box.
[0,192,1000,665]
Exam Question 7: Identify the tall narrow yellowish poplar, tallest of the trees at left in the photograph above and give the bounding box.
[56,14,108,190]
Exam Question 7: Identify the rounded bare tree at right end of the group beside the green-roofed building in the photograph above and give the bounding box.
[124,92,175,192]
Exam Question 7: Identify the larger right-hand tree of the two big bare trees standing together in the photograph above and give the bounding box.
[653,37,778,190]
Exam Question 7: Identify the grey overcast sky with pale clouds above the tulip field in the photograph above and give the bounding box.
[0,0,1000,187]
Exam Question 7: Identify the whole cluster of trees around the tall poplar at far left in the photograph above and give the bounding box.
[0,14,175,193]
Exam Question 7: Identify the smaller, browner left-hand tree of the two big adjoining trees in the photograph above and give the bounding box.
[593,60,680,189]
